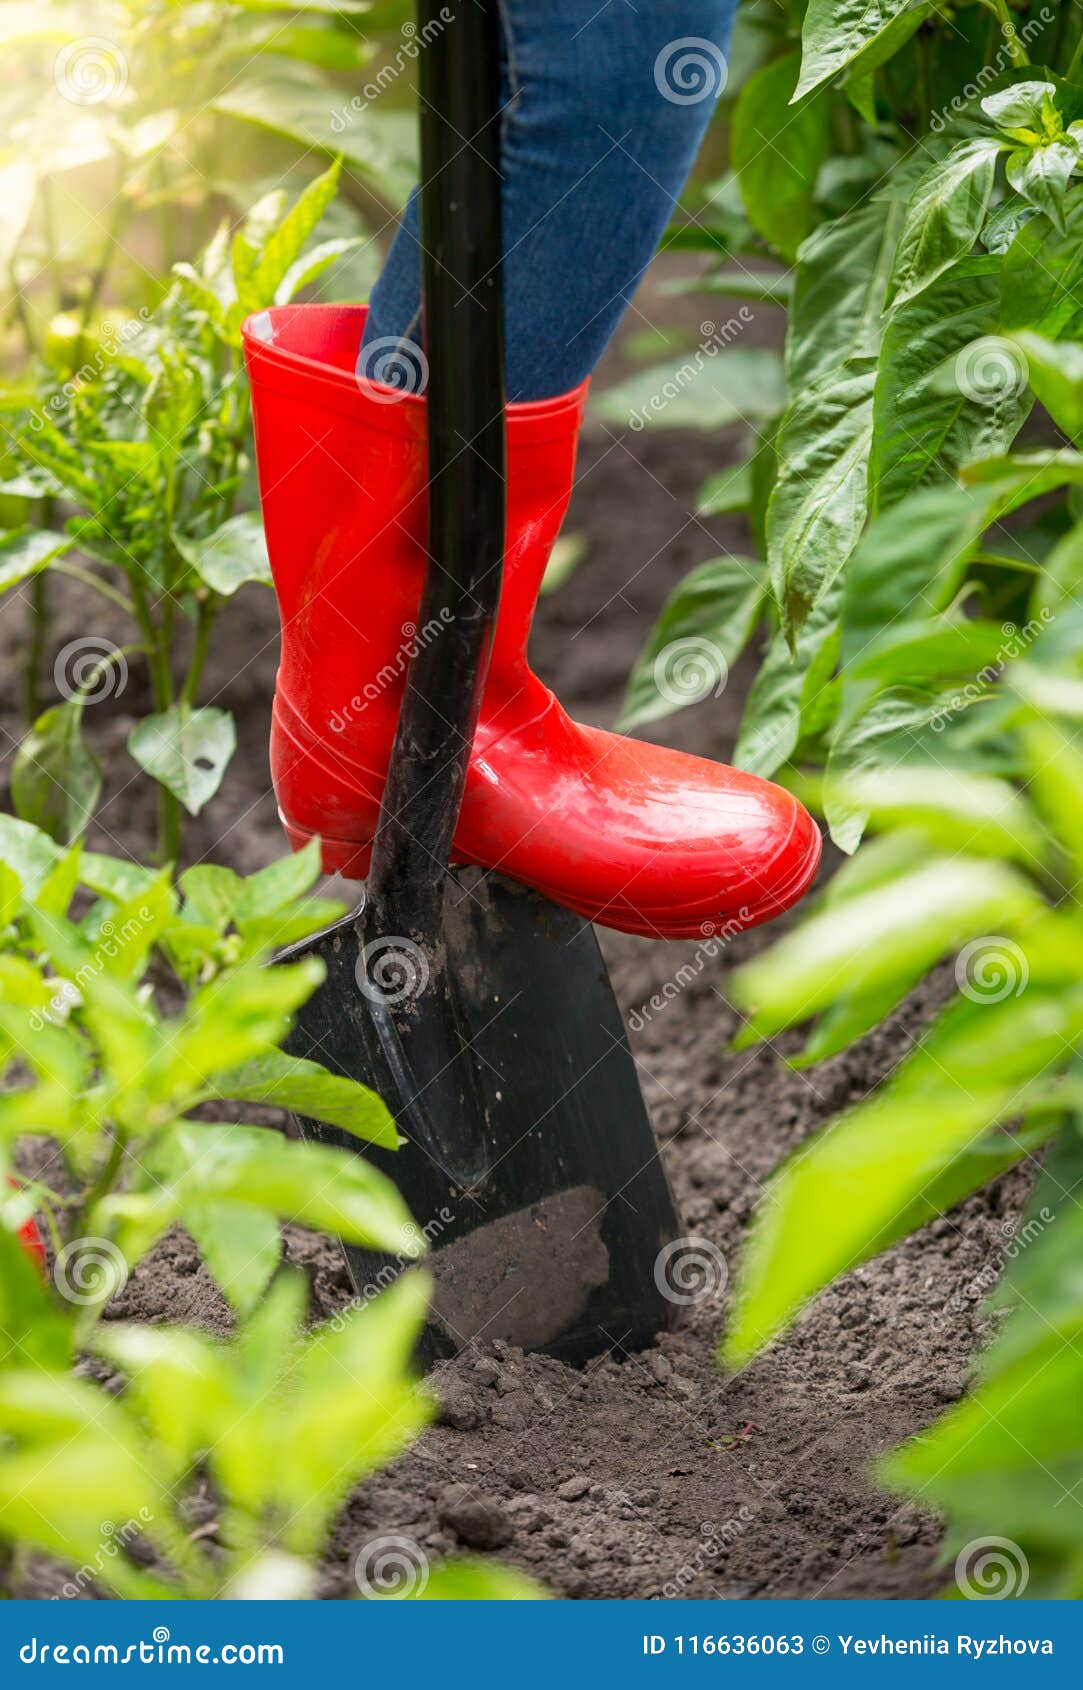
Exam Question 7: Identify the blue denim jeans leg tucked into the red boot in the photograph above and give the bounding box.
[358,0,737,399]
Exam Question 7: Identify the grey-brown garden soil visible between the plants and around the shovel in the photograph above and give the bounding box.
[0,287,1026,1599]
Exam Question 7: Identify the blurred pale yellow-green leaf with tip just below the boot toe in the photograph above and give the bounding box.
[732,855,1037,1038]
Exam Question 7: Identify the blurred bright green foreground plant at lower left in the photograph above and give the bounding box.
[0,816,537,1597]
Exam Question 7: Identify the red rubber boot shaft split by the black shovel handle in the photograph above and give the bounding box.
[245,306,586,743]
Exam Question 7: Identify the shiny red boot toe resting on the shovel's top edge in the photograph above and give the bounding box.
[463,711,821,938]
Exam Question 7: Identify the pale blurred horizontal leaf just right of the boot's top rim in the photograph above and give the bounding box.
[593,344,786,429]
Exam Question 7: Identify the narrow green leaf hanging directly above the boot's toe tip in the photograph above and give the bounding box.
[733,592,838,776]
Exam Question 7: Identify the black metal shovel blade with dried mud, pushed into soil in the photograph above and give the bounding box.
[287,869,679,1364]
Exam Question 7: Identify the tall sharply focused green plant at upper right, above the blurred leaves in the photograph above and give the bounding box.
[607,0,1083,767]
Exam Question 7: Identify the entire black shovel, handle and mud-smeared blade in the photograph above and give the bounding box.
[286,0,678,1362]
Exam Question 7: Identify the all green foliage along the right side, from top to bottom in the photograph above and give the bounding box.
[594,0,1083,1597]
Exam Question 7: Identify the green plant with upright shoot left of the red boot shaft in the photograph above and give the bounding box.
[0,164,353,862]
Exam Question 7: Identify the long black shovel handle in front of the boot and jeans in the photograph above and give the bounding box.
[365,0,505,945]
